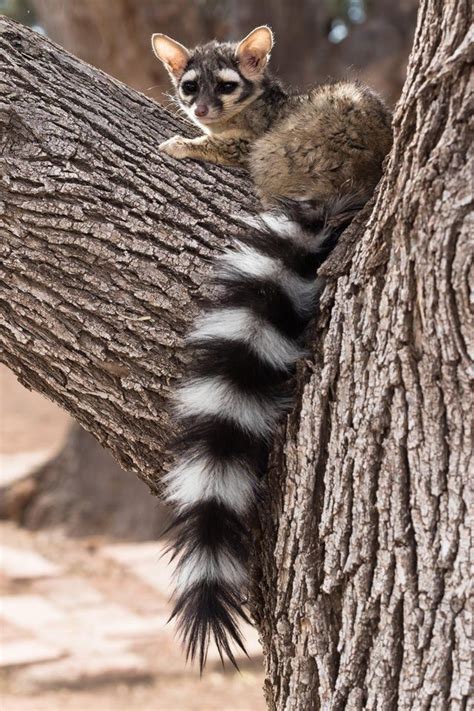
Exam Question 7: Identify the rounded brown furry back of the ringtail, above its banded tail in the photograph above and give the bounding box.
[249,82,392,204]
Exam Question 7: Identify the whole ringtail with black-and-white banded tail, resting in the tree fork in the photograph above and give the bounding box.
[152,27,392,669]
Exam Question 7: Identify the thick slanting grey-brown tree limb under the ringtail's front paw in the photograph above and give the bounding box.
[0,18,252,490]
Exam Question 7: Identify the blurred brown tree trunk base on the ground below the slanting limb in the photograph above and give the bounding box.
[11,425,167,541]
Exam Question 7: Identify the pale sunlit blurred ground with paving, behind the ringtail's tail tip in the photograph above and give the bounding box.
[0,366,266,711]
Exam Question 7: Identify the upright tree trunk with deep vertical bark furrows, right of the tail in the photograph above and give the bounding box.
[254,0,473,711]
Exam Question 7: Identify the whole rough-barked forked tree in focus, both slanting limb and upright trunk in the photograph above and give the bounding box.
[0,5,470,711]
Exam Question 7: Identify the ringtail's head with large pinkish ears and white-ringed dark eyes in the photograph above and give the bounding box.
[151,26,273,132]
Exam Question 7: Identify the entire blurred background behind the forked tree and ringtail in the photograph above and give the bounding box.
[0,0,417,711]
